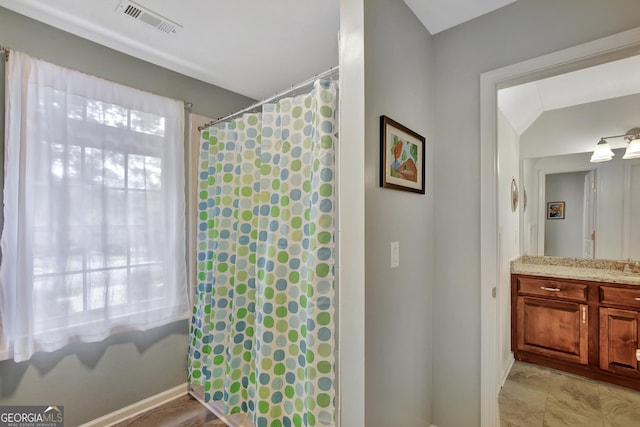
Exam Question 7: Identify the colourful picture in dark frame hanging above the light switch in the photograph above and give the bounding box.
[380,116,425,194]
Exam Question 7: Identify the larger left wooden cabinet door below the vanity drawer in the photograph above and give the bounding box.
[516,296,589,365]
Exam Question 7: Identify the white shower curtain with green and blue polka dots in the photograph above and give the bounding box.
[189,80,337,427]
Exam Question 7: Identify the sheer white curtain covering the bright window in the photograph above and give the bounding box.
[0,51,188,361]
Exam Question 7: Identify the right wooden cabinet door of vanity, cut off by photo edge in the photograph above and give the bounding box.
[600,307,640,377]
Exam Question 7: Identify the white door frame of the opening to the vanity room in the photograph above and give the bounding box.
[480,28,640,427]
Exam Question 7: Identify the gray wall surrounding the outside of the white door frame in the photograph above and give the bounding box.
[430,0,640,427]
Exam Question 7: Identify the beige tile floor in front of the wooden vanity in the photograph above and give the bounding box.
[498,361,640,427]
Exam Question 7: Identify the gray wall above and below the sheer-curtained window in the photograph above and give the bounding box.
[0,8,252,426]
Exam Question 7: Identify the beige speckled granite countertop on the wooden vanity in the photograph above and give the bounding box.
[511,255,640,286]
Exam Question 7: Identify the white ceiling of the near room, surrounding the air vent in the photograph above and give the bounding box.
[0,0,514,99]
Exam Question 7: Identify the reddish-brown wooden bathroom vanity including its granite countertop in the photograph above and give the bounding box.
[511,256,640,390]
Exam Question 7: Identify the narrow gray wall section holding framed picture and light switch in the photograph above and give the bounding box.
[364,0,434,427]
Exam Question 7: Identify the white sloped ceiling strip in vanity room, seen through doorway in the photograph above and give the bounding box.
[498,56,640,136]
